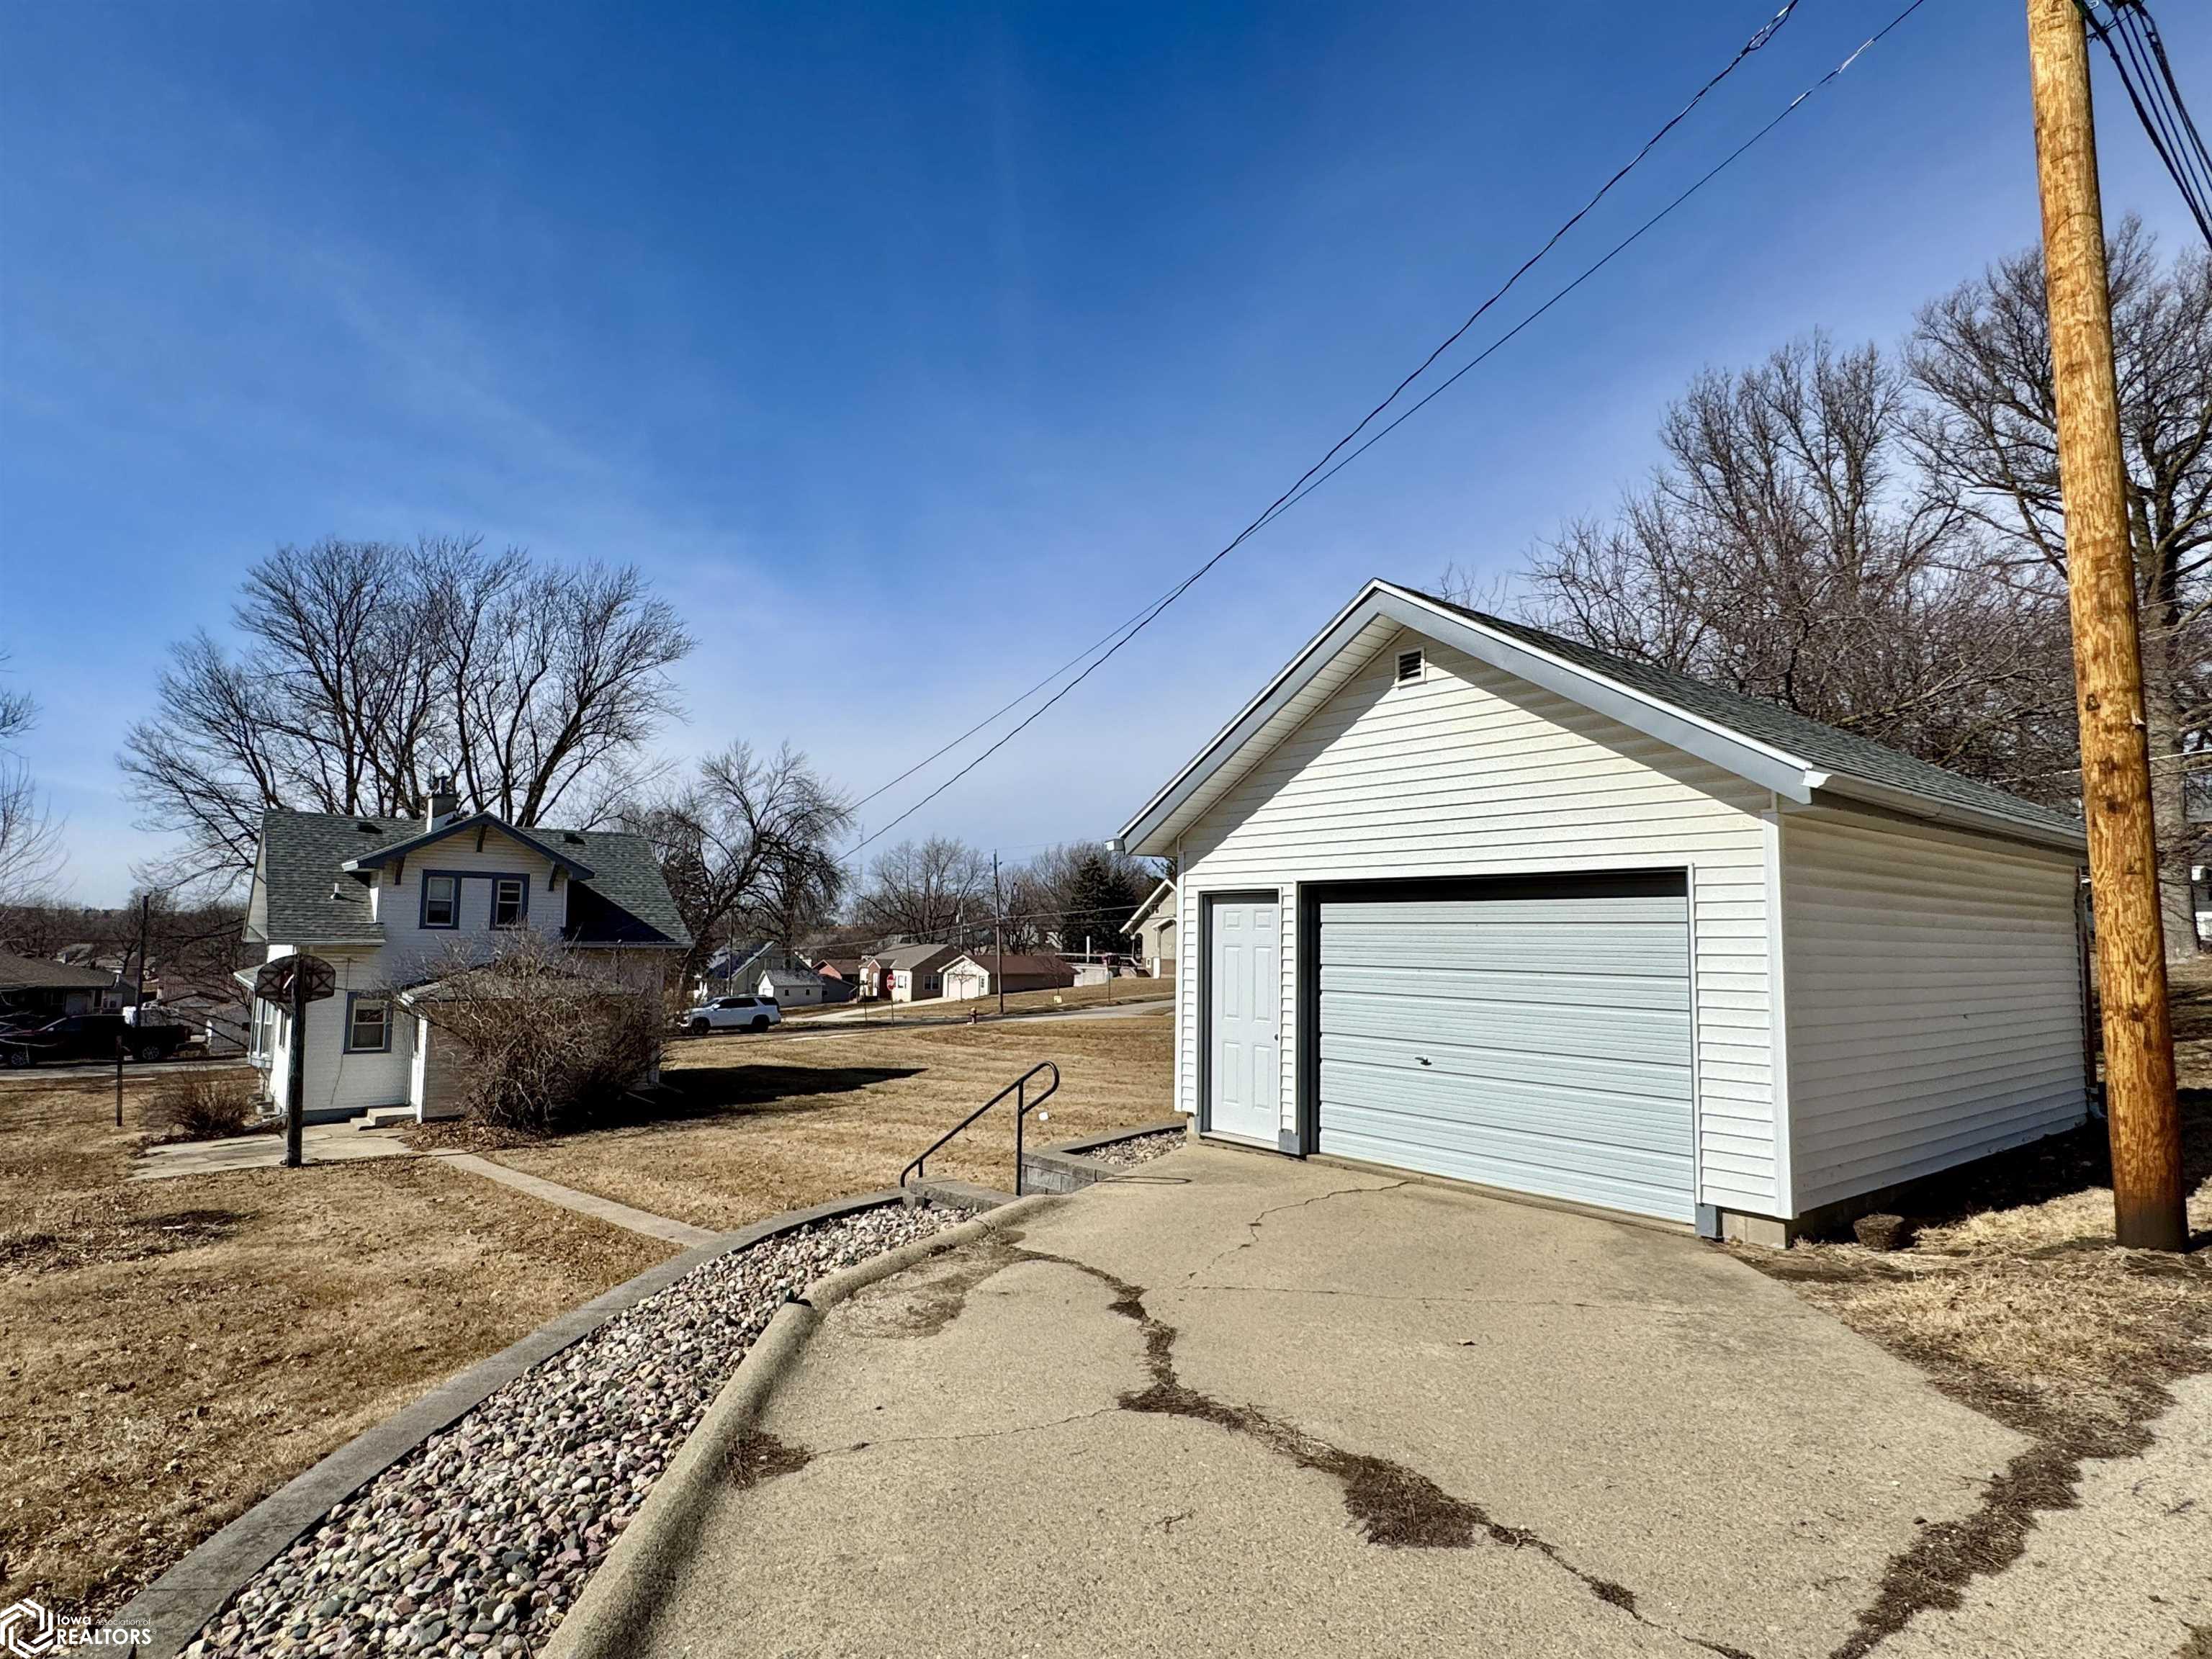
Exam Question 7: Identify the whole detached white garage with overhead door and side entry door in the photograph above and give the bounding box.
[1122,582,2088,1241]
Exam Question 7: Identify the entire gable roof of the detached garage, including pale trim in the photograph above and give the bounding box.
[1122,582,2086,856]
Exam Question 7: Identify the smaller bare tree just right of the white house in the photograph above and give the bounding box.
[626,743,852,978]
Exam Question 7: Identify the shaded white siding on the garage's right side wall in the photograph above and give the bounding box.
[1781,811,2088,1212]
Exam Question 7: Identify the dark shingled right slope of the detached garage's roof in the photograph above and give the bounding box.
[1420,593,2082,836]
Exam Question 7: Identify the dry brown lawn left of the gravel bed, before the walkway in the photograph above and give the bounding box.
[0,1071,670,1615]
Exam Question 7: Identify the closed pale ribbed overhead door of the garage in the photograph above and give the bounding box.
[1318,889,1694,1221]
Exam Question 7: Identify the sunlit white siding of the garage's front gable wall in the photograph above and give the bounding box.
[1177,633,1781,1215]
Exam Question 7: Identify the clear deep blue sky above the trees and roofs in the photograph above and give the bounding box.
[0,0,2212,902]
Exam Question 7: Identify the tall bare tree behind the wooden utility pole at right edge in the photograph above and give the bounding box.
[1909,217,2212,956]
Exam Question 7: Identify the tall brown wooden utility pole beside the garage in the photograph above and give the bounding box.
[2028,0,2188,1250]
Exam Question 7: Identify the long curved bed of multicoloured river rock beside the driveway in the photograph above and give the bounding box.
[186,1203,966,1659]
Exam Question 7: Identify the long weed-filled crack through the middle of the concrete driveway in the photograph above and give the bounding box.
[1020,1256,1752,1659]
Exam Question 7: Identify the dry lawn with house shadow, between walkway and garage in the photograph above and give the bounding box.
[449,1004,1174,1228]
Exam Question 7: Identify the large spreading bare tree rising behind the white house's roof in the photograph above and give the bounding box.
[120,537,693,887]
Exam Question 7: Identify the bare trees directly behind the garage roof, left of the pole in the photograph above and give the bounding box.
[1495,336,2075,814]
